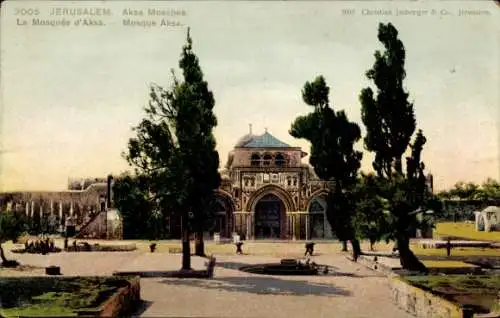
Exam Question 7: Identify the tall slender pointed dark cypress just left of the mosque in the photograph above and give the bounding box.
[176,31,221,256]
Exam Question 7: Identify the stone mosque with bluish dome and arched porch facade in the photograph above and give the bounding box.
[182,130,332,240]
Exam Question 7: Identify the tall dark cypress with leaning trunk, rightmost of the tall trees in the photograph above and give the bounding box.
[360,23,429,271]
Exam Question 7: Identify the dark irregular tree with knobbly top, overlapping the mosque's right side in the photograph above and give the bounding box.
[289,76,362,259]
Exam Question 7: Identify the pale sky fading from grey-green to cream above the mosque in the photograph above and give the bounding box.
[0,1,500,191]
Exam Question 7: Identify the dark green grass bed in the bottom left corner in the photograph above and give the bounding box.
[0,277,129,317]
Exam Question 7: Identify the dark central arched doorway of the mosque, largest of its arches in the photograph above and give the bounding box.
[254,194,286,239]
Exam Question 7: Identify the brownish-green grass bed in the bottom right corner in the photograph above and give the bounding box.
[405,275,500,313]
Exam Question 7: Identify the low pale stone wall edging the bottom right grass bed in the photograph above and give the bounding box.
[390,276,472,318]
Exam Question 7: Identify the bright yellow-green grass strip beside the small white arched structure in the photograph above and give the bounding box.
[433,222,500,242]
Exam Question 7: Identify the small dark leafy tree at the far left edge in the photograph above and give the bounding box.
[0,211,28,266]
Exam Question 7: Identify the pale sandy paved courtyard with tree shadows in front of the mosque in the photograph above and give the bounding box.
[0,245,412,318]
